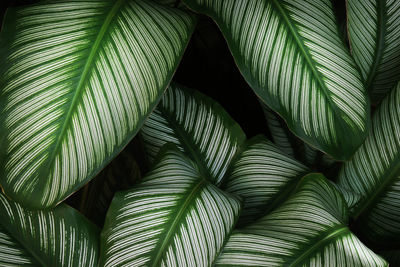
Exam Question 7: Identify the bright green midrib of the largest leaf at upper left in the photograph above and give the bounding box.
[39,0,125,186]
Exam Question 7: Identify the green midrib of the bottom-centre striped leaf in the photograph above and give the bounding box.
[151,178,207,267]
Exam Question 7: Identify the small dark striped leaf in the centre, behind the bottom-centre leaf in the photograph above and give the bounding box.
[141,85,245,184]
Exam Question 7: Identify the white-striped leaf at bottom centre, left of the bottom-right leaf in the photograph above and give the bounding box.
[100,146,240,267]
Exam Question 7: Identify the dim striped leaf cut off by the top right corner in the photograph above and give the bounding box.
[346,0,400,102]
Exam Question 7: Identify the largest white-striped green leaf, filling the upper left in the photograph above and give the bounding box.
[0,0,194,208]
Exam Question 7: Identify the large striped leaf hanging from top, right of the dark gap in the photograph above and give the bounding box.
[183,0,369,160]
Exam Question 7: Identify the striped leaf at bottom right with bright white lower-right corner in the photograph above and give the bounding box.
[216,174,387,267]
